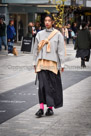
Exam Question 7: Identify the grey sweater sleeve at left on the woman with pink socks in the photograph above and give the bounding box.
[33,34,39,66]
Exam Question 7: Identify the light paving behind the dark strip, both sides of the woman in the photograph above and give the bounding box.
[0,44,91,93]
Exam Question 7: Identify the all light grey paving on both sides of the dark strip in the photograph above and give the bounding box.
[0,45,91,136]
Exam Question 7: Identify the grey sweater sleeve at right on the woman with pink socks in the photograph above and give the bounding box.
[58,33,65,68]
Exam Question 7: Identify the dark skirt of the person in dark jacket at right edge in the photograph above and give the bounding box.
[76,49,90,61]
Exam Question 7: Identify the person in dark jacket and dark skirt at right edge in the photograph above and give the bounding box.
[75,22,91,67]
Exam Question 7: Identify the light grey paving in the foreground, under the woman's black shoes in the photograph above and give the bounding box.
[0,77,91,136]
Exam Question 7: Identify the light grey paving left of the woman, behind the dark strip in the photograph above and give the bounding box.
[0,44,36,93]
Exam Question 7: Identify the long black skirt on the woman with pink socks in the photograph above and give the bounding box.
[38,70,63,108]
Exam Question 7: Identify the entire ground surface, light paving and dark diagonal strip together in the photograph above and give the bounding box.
[0,44,91,136]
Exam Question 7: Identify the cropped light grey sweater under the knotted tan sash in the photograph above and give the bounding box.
[33,28,65,68]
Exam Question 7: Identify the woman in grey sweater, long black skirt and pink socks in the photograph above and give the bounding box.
[33,14,65,117]
